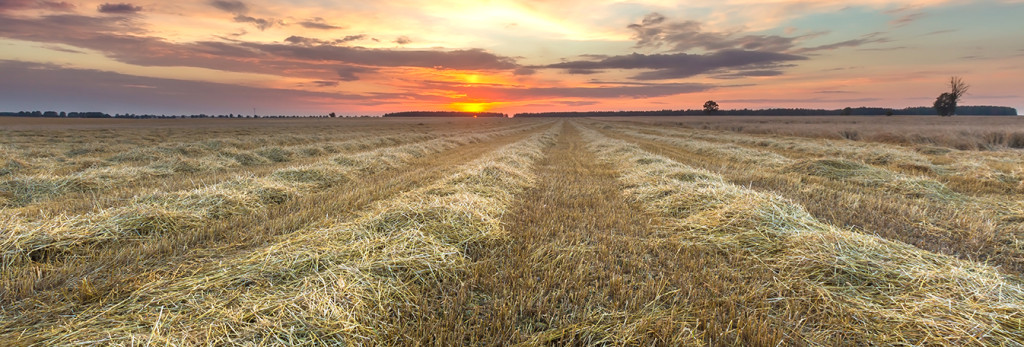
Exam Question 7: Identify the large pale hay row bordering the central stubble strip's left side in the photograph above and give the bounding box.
[0,122,559,345]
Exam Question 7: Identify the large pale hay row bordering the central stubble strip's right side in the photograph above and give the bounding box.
[585,124,1024,345]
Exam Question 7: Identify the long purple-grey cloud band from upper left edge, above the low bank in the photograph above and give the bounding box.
[0,13,522,89]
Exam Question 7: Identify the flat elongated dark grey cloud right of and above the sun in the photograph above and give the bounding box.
[545,50,806,80]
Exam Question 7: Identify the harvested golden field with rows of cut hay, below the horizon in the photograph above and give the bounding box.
[0,117,1024,346]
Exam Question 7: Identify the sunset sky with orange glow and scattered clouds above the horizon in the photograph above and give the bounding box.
[0,0,1024,116]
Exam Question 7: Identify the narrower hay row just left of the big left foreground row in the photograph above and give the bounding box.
[0,123,552,266]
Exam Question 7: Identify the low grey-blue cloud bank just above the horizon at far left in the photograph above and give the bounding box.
[0,60,387,115]
